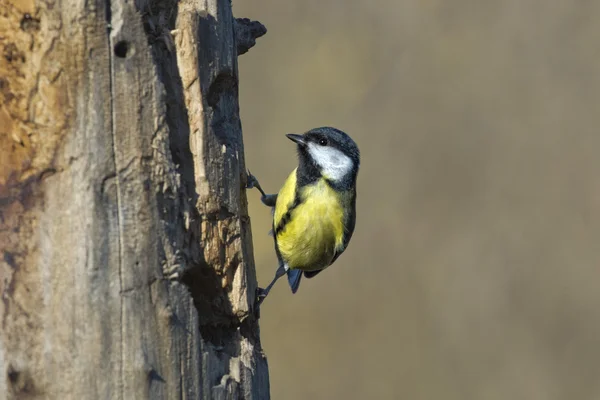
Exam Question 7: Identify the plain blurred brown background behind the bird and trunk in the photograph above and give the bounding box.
[233,0,600,400]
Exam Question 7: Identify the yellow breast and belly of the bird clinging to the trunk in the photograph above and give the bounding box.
[273,170,344,271]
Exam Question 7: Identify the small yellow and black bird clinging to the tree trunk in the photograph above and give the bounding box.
[246,127,360,305]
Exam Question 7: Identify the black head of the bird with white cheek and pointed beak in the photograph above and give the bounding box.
[287,127,360,187]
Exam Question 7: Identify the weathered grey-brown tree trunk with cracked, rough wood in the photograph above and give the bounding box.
[0,0,269,399]
